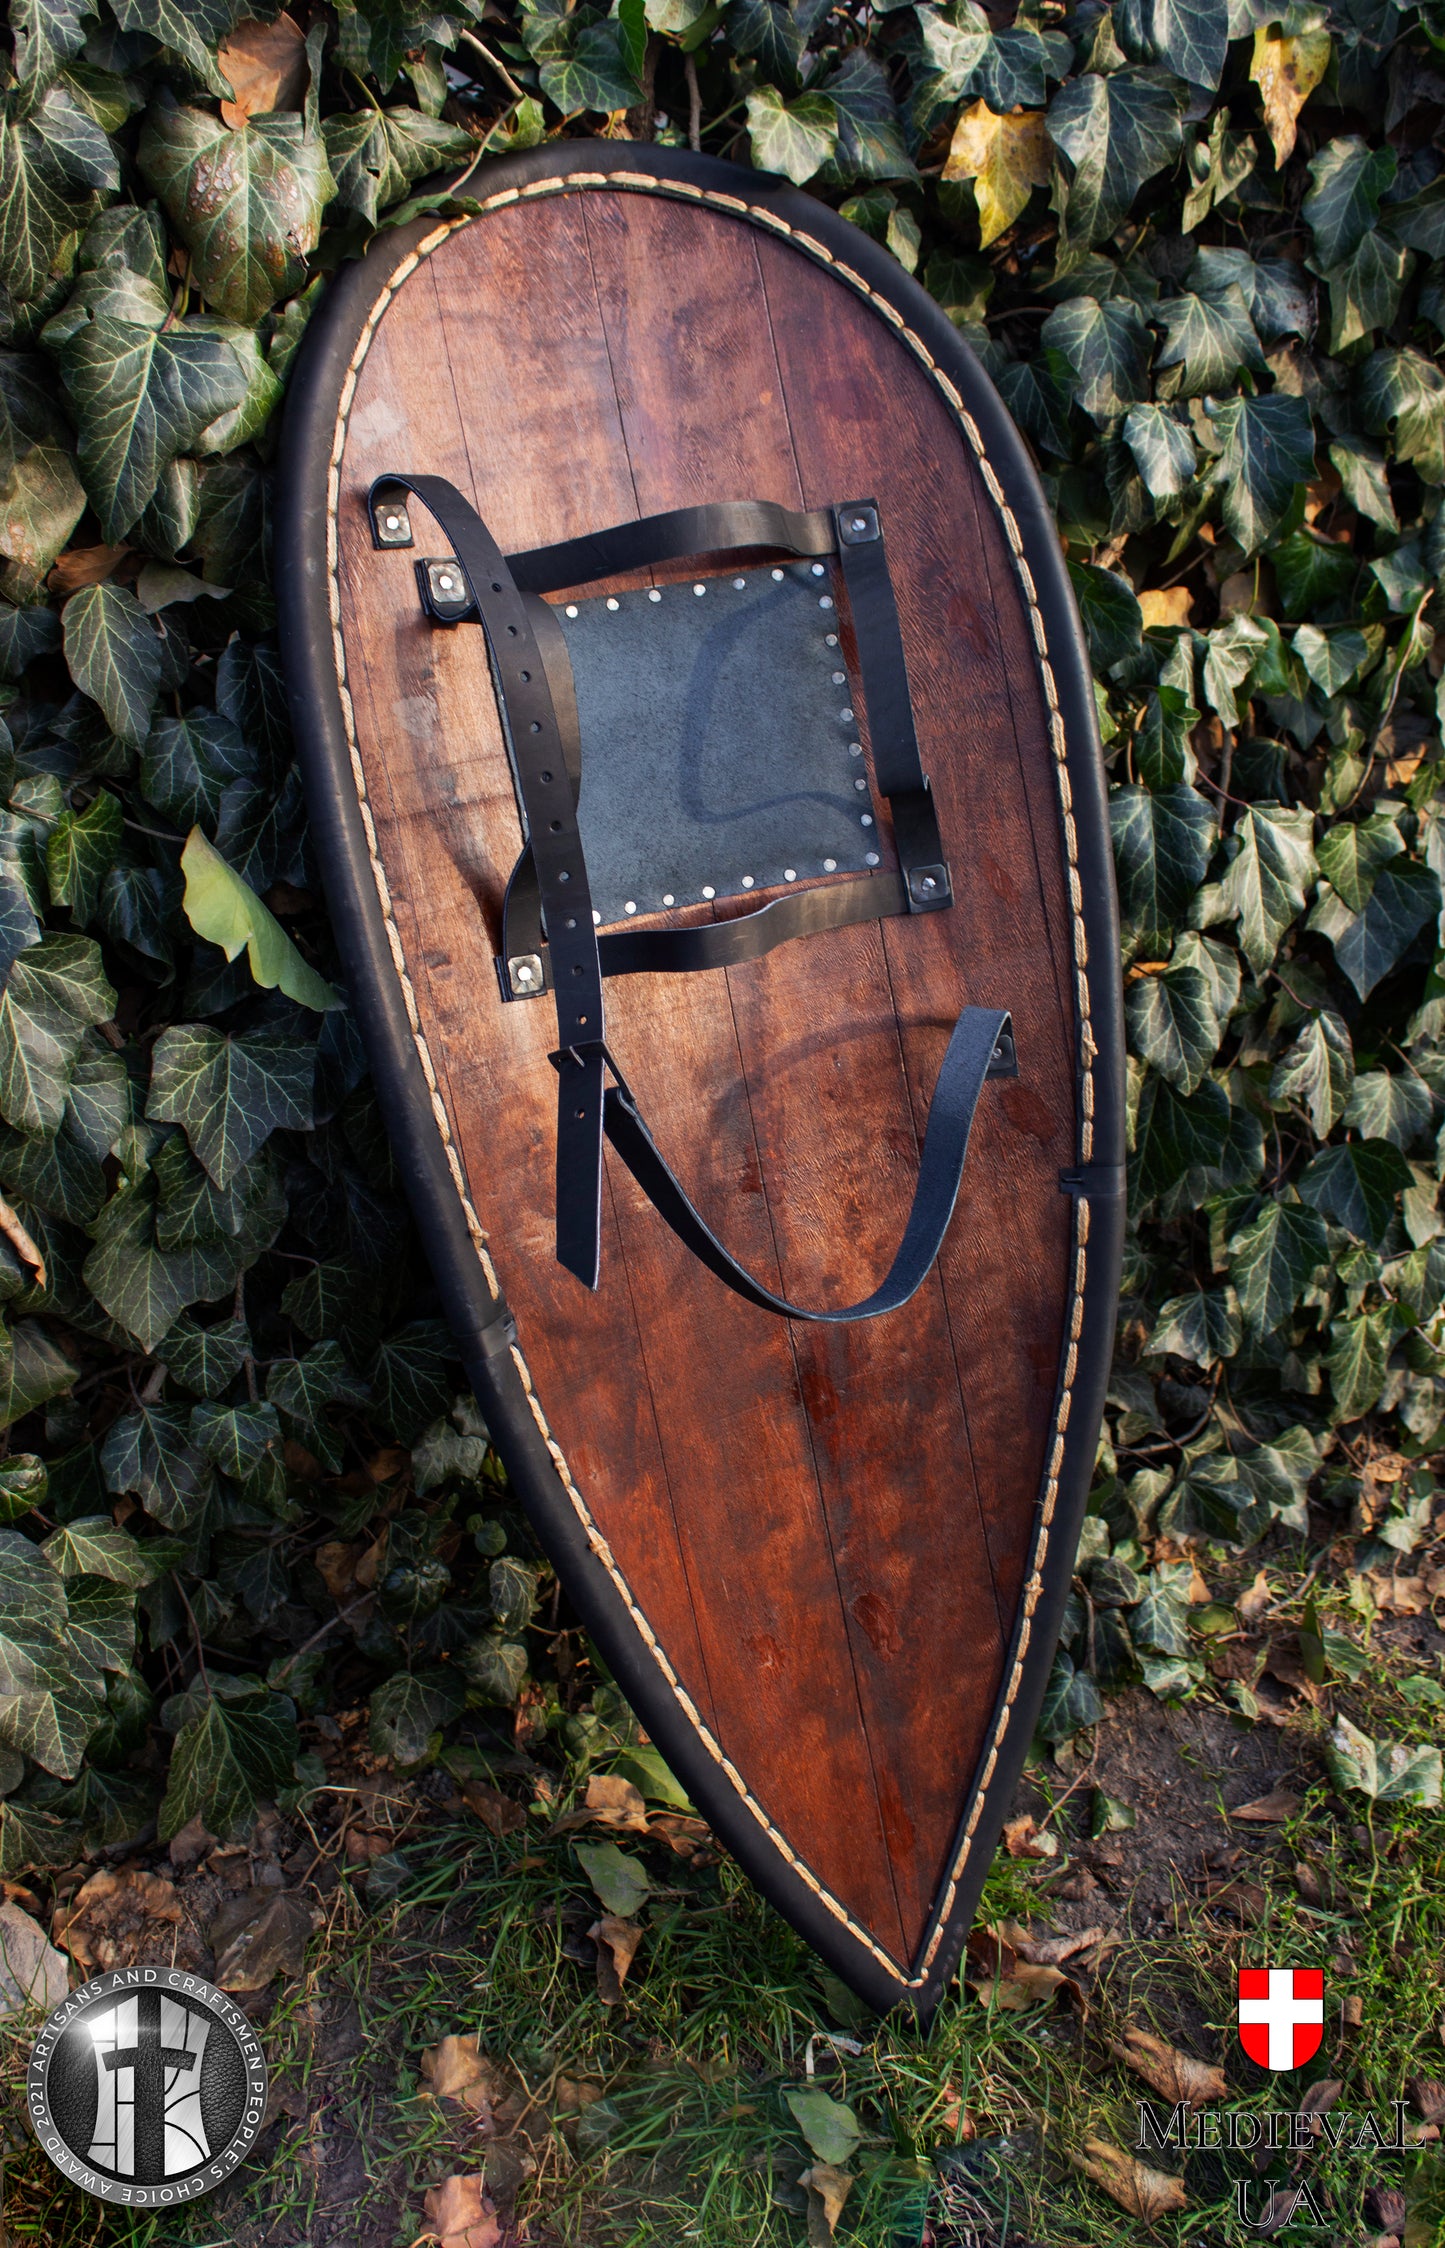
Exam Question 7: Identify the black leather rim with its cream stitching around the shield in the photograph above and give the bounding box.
[276,142,1124,2023]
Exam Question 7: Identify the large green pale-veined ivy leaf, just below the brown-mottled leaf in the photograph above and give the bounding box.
[52,312,247,540]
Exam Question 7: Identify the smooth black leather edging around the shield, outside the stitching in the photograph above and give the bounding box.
[274,142,1124,2021]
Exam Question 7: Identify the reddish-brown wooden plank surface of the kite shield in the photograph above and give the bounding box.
[339,191,1074,1958]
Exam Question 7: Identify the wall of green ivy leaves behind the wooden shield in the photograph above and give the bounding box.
[0,0,1445,1873]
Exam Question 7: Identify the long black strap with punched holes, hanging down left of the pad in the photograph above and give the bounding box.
[371,474,605,1288]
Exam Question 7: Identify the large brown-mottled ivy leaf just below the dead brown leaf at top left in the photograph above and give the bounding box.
[137,95,337,326]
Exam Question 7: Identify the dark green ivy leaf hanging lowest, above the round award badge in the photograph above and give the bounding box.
[155,1673,301,1841]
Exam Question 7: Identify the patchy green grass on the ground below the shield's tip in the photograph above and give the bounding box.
[2,1610,1445,2248]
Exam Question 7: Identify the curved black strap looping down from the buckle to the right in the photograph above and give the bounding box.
[584,1007,1009,1326]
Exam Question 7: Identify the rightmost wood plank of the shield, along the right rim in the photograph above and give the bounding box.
[762,243,1074,1612]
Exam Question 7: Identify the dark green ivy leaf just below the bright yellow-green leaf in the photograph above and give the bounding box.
[146,1023,315,1187]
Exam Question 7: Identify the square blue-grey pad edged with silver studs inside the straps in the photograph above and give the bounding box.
[555,562,879,922]
